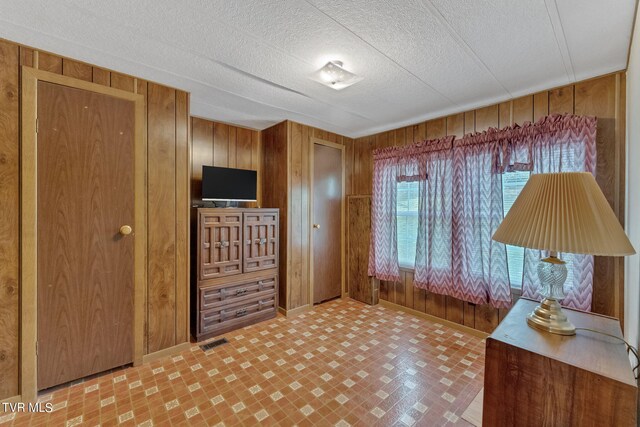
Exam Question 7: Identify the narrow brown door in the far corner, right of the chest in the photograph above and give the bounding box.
[312,143,343,304]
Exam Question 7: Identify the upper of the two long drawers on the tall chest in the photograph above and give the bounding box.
[198,275,277,310]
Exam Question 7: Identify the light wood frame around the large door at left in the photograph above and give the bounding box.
[19,66,147,401]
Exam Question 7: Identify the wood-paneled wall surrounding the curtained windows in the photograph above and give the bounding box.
[347,72,625,332]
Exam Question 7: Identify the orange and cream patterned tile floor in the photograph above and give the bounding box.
[0,299,484,427]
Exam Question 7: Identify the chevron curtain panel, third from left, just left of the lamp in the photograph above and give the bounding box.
[447,134,511,308]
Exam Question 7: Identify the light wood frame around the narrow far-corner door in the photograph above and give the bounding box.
[309,137,349,308]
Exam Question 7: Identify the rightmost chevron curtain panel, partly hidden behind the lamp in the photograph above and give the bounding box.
[522,115,597,311]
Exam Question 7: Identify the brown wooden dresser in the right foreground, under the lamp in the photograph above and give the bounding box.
[482,298,638,427]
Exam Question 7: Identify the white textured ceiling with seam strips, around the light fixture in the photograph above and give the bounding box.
[0,0,635,137]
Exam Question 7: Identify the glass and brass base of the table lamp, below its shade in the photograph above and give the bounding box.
[527,253,576,335]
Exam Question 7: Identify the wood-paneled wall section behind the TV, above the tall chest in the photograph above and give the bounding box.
[191,117,261,205]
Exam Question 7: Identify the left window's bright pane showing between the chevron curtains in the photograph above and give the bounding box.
[396,181,419,268]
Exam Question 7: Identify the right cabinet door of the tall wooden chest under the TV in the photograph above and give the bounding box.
[243,211,278,273]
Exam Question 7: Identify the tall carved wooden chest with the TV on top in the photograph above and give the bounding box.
[191,208,279,341]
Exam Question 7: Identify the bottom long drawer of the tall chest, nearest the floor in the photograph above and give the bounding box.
[199,292,276,335]
